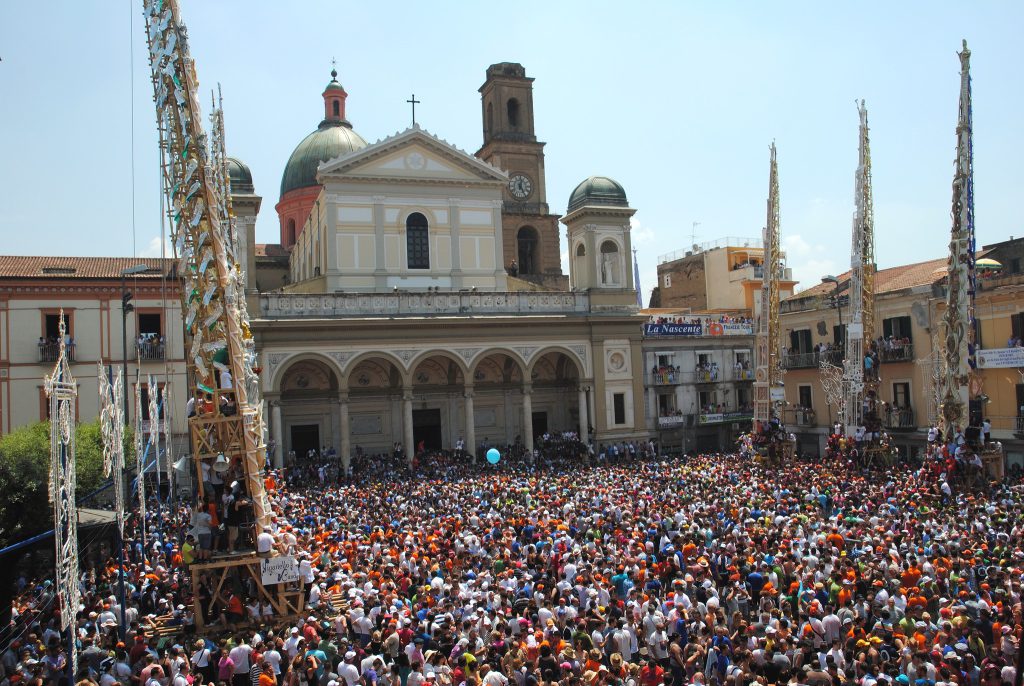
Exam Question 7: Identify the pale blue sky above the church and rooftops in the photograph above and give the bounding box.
[0,0,1024,299]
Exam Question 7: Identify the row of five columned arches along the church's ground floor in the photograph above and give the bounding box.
[265,347,594,466]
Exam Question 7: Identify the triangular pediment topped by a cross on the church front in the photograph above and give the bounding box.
[317,128,508,184]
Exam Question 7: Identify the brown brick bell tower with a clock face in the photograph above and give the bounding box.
[476,62,568,291]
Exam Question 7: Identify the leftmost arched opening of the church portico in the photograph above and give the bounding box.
[281,358,339,462]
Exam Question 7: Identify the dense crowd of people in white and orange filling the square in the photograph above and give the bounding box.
[0,434,1024,686]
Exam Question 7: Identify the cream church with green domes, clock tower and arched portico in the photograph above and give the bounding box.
[231,63,648,465]
